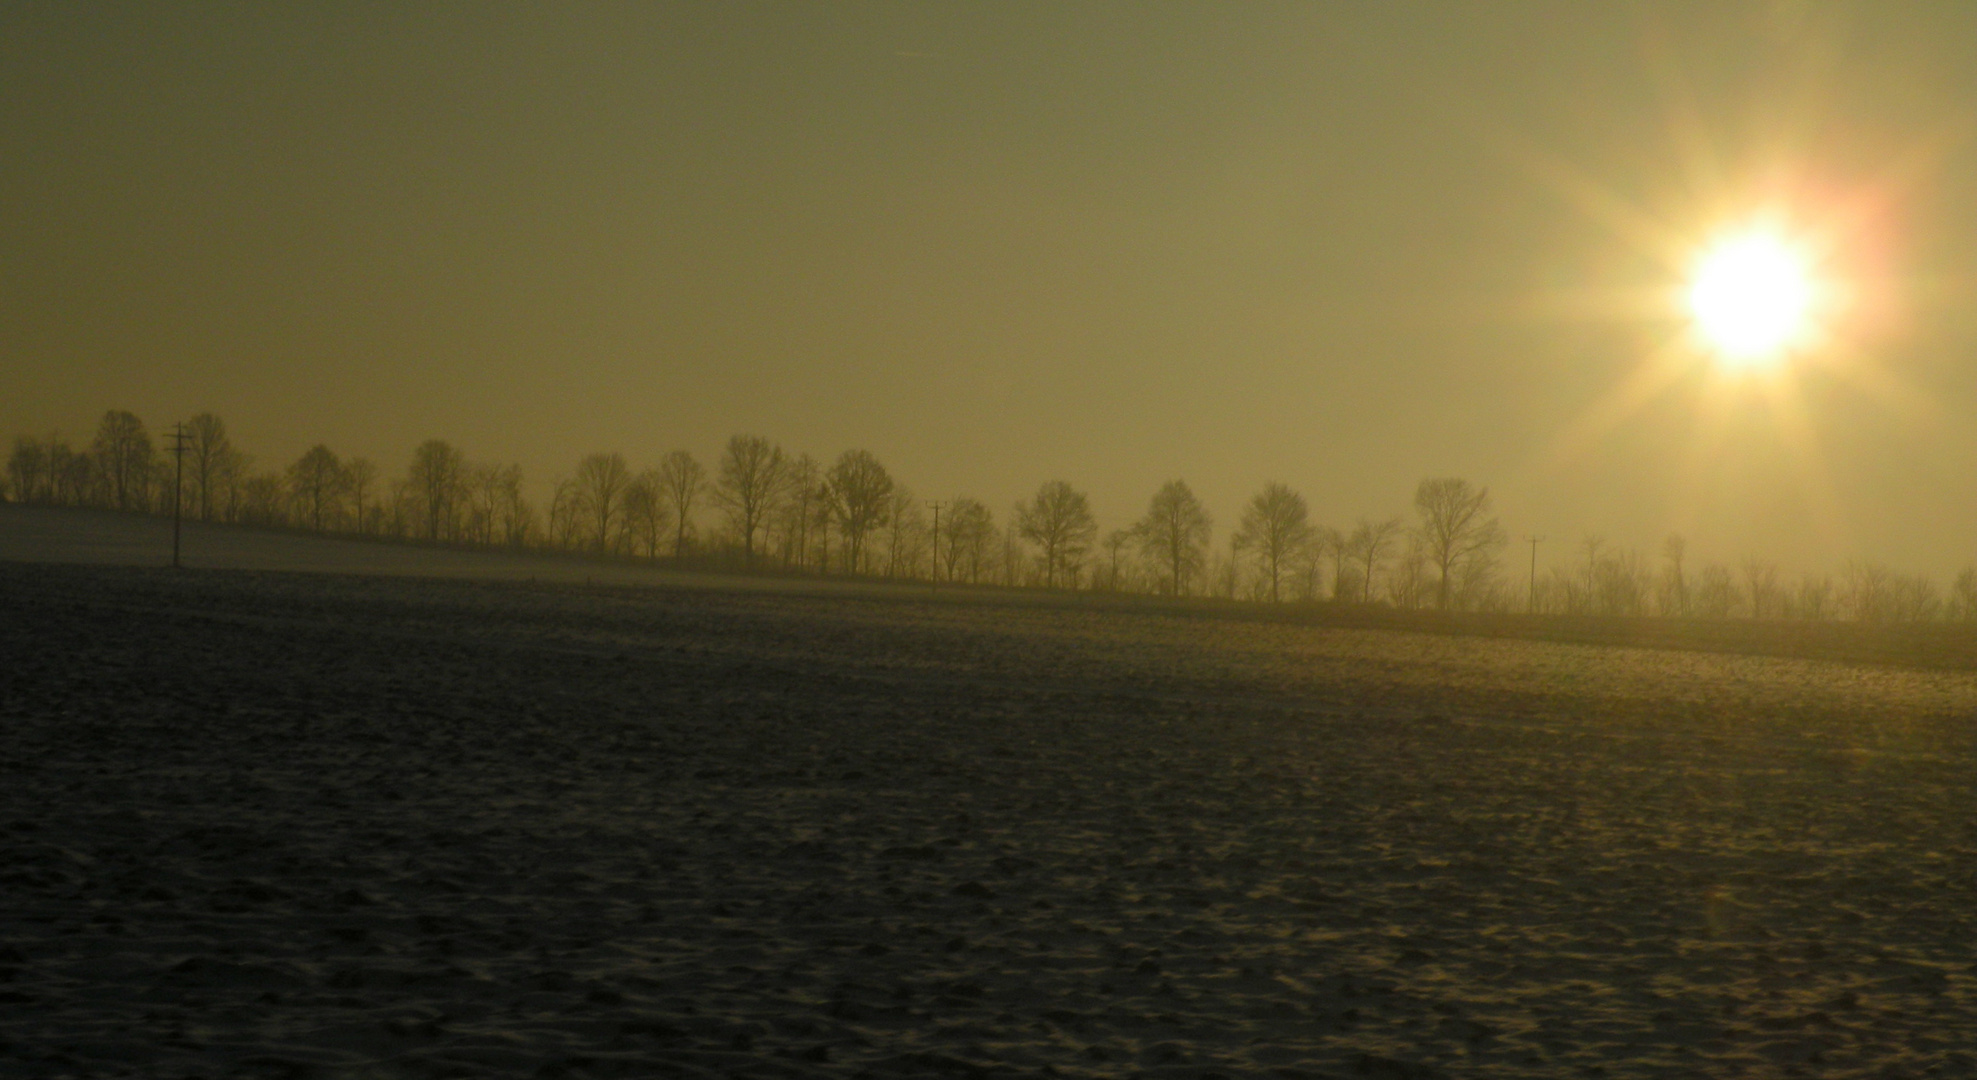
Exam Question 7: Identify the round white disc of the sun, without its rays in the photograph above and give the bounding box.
[1688,227,1819,368]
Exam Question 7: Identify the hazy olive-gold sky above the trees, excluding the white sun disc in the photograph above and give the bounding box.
[0,0,1977,574]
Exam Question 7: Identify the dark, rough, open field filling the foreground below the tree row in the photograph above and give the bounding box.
[0,564,1977,1078]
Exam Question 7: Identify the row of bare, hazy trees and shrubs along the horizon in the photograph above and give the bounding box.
[0,409,1977,623]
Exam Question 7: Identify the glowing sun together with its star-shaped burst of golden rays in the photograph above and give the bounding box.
[1503,6,1969,534]
